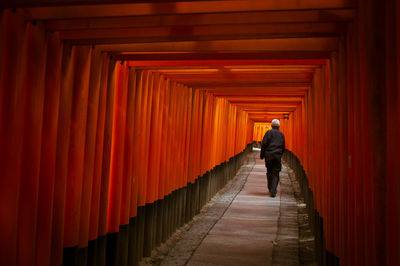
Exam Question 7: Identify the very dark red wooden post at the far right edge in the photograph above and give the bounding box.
[385,1,400,265]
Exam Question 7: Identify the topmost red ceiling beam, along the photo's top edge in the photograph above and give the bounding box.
[19,0,356,20]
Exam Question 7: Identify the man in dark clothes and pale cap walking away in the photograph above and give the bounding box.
[260,119,285,197]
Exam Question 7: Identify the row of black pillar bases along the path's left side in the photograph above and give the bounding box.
[63,144,252,266]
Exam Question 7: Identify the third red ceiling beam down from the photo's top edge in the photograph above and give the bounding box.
[60,23,346,44]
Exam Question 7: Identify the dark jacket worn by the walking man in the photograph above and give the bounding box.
[260,128,285,161]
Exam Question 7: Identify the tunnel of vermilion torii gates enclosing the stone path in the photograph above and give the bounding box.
[0,0,400,266]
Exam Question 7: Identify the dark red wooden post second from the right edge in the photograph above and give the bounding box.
[358,1,386,265]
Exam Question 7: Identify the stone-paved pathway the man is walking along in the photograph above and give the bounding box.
[152,152,299,266]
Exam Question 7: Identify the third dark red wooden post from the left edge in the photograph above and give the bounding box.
[35,34,62,266]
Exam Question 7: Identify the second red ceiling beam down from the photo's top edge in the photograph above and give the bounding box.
[46,9,356,31]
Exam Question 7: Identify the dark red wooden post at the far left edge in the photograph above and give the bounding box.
[0,10,25,265]
